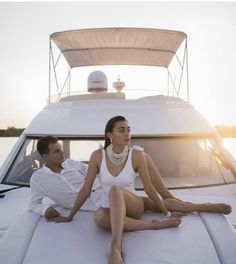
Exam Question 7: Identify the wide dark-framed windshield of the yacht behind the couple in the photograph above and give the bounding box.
[4,137,235,189]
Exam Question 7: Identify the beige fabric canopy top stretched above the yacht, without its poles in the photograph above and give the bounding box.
[50,28,187,68]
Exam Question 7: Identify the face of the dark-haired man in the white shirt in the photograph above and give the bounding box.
[43,142,65,165]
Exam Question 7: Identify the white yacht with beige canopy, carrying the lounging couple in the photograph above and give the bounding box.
[0,28,236,264]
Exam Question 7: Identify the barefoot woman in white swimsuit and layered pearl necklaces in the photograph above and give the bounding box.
[53,116,229,264]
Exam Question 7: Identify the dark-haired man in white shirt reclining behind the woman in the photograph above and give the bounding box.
[29,136,101,219]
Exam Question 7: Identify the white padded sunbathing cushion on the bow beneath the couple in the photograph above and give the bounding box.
[0,210,236,264]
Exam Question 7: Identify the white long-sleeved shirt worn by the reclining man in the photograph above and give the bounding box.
[29,159,101,216]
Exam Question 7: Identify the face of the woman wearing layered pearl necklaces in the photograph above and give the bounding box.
[107,121,131,146]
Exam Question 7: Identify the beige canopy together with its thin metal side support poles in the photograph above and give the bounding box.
[49,28,189,103]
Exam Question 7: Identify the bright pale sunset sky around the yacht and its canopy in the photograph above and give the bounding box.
[0,1,236,129]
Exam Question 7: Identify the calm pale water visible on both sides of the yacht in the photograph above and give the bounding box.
[0,137,236,167]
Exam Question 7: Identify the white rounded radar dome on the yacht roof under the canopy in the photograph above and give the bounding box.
[88,71,107,92]
